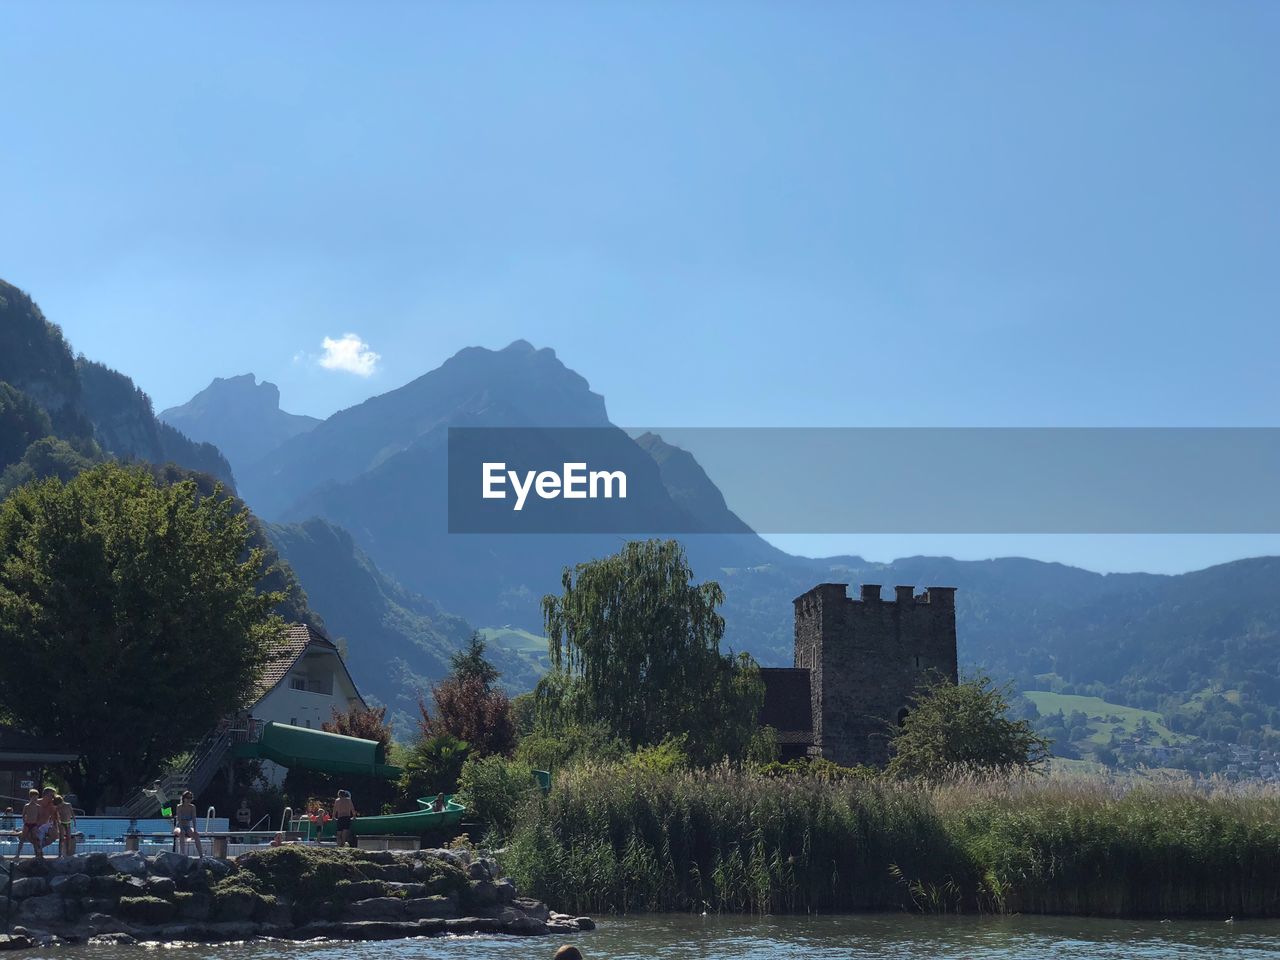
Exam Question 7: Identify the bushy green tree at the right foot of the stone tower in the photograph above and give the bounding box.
[888,676,1050,780]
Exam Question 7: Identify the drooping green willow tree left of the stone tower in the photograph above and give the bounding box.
[539,540,764,759]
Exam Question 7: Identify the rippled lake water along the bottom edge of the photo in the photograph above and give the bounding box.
[8,914,1280,960]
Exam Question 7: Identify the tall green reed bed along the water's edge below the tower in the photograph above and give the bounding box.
[507,765,1280,918]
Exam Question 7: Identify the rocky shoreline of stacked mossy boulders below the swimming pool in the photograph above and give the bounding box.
[0,845,595,950]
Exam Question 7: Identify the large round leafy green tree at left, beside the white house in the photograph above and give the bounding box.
[0,463,280,809]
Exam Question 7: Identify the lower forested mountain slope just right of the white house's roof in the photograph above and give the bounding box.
[268,517,541,736]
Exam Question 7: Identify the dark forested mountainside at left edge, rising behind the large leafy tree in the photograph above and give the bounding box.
[0,280,232,486]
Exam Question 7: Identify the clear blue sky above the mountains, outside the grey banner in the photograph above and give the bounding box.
[0,0,1280,570]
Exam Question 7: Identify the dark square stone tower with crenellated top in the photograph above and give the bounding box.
[795,584,957,767]
